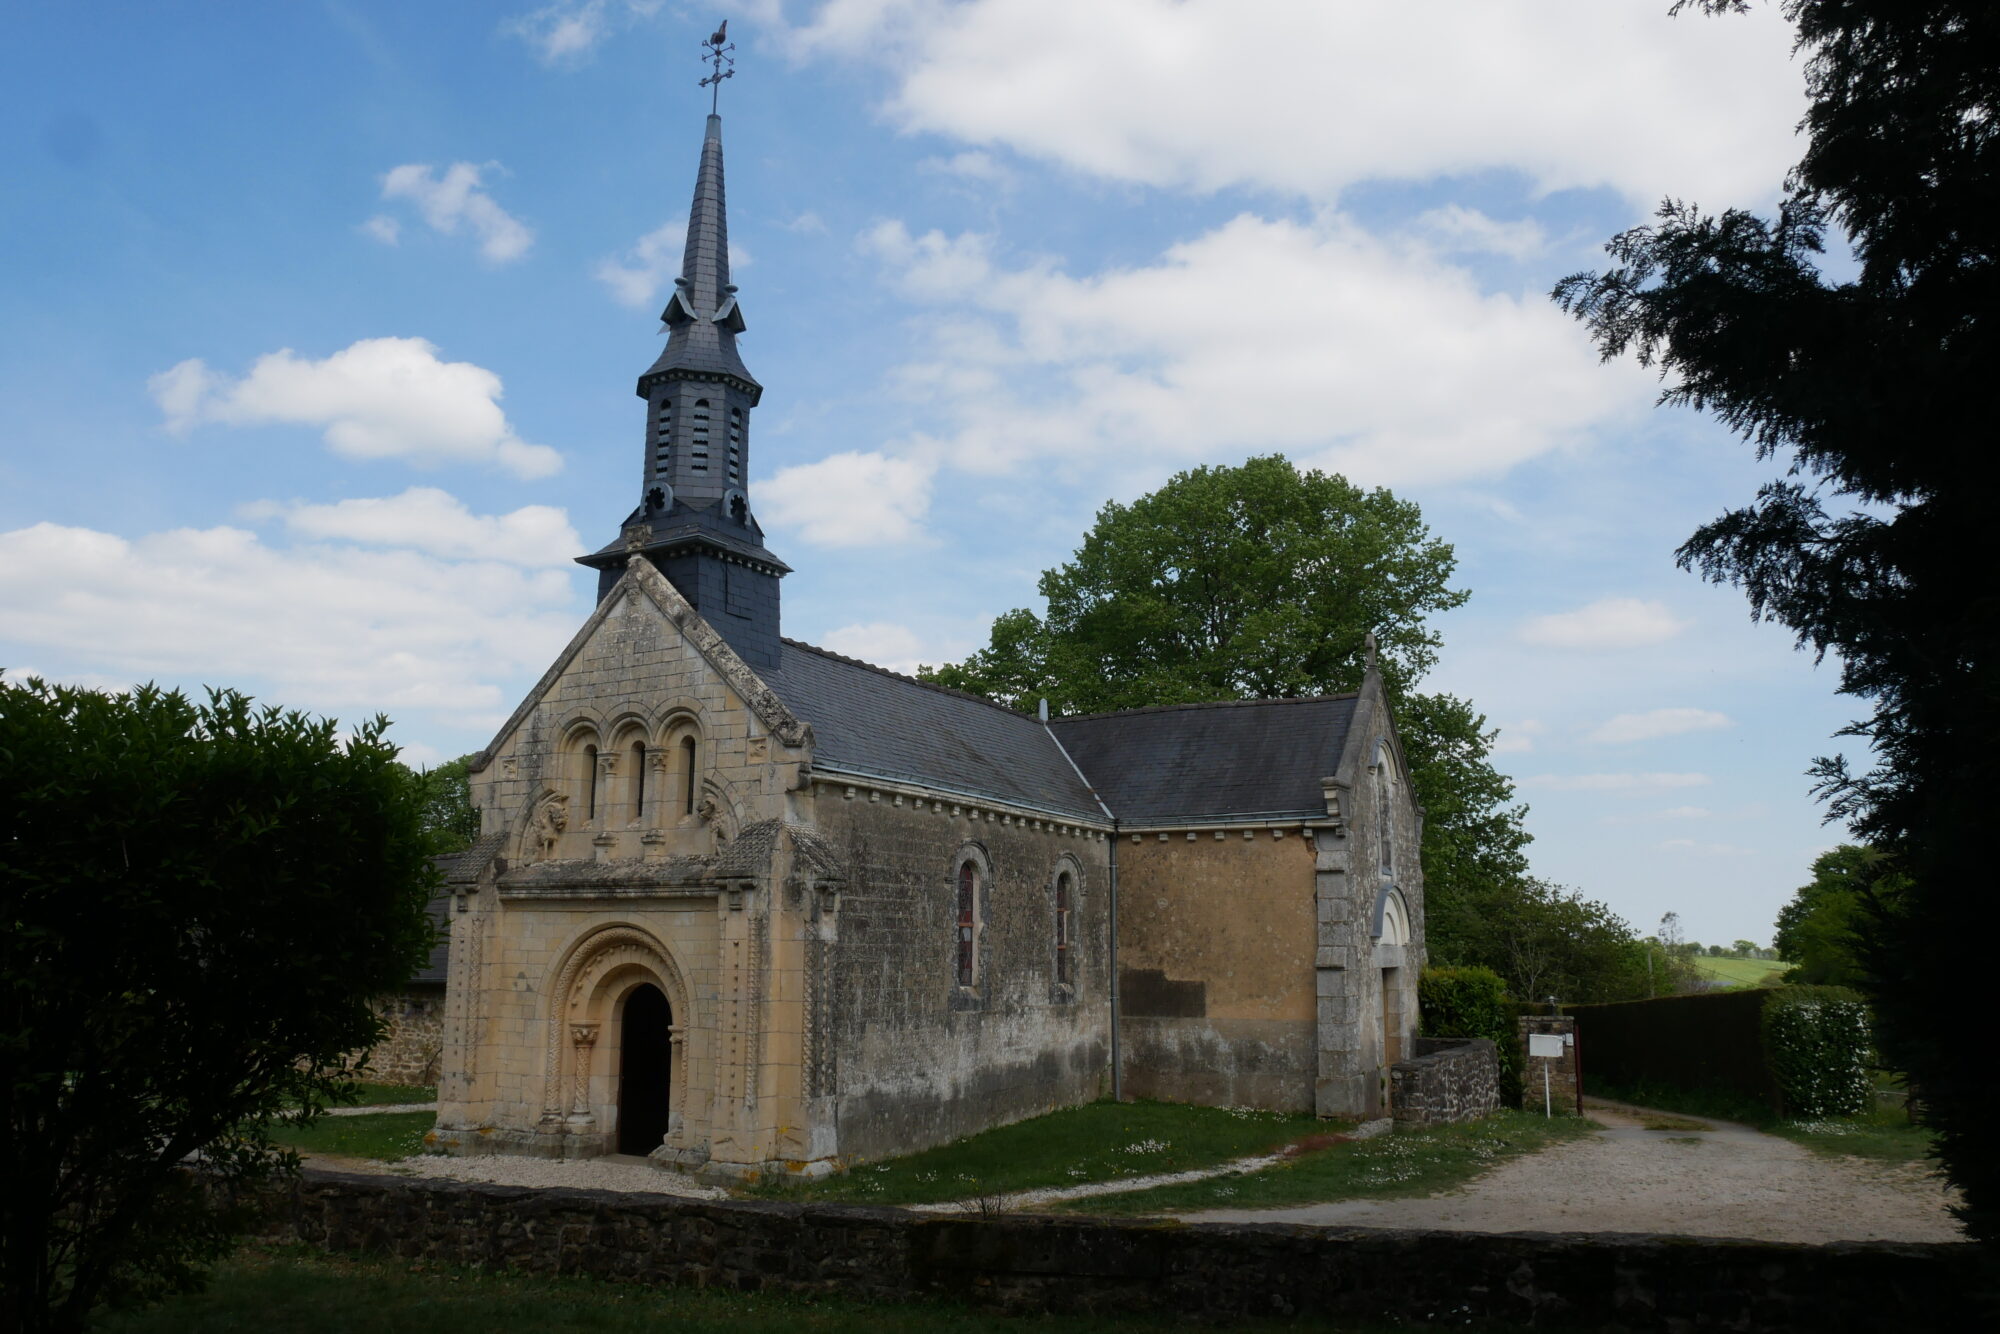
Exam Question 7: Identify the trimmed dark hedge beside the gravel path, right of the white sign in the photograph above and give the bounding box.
[1568,986,1868,1116]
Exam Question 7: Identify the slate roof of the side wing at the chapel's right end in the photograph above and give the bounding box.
[1050,694,1358,824]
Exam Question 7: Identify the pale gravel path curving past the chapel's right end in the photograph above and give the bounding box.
[1186,1104,1964,1242]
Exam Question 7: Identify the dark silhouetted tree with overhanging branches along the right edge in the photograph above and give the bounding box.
[1556,0,2000,1242]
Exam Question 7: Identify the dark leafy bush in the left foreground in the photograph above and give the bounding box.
[0,680,434,1332]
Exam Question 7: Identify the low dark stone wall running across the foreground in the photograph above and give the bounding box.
[268,1172,1978,1334]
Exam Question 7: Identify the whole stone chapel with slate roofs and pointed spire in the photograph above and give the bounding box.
[426,116,1424,1178]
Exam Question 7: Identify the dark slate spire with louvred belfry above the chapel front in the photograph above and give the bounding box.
[578,96,790,668]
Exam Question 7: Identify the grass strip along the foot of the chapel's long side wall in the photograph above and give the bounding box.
[748,1102,1346,1204]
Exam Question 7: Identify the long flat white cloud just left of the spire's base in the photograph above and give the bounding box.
[242,486,584,570]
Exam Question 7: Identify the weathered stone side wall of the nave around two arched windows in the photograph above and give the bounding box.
[816,782,1110,1158]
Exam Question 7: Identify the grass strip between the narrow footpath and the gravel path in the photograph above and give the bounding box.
[1056,1112,1596,1214]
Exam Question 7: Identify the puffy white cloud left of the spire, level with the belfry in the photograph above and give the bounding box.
[148,338,562,478]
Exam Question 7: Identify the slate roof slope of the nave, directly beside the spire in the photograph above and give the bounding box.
[758,640,1104,822]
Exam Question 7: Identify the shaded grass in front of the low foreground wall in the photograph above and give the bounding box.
[94,1248,1498,1334]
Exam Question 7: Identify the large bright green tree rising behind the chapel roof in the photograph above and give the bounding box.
[918,454,1528,948]
